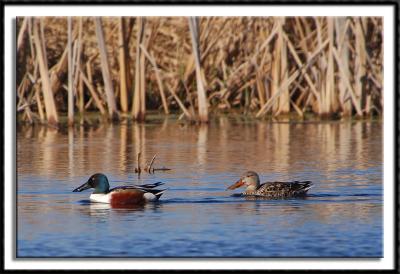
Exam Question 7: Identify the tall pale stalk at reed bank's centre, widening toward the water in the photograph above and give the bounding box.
[189,17,208,122]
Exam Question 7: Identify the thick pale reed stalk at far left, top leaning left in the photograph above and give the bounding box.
[33,20,58,125]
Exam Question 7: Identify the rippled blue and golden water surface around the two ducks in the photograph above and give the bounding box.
[16,117,383,257]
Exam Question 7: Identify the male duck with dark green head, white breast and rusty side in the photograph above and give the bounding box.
[73,173,165,205]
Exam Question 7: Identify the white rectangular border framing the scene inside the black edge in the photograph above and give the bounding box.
[4,4,395,269]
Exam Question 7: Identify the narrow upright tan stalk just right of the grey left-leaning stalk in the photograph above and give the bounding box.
[118,17,128,112]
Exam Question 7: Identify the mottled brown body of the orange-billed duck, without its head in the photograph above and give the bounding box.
[245,181,312,198]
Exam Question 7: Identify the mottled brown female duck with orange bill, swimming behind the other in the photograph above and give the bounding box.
[227,171,313,199]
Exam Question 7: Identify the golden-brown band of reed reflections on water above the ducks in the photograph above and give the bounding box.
[17,118,383,182]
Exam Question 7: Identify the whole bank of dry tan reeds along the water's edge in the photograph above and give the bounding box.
[16,17,383,127]
